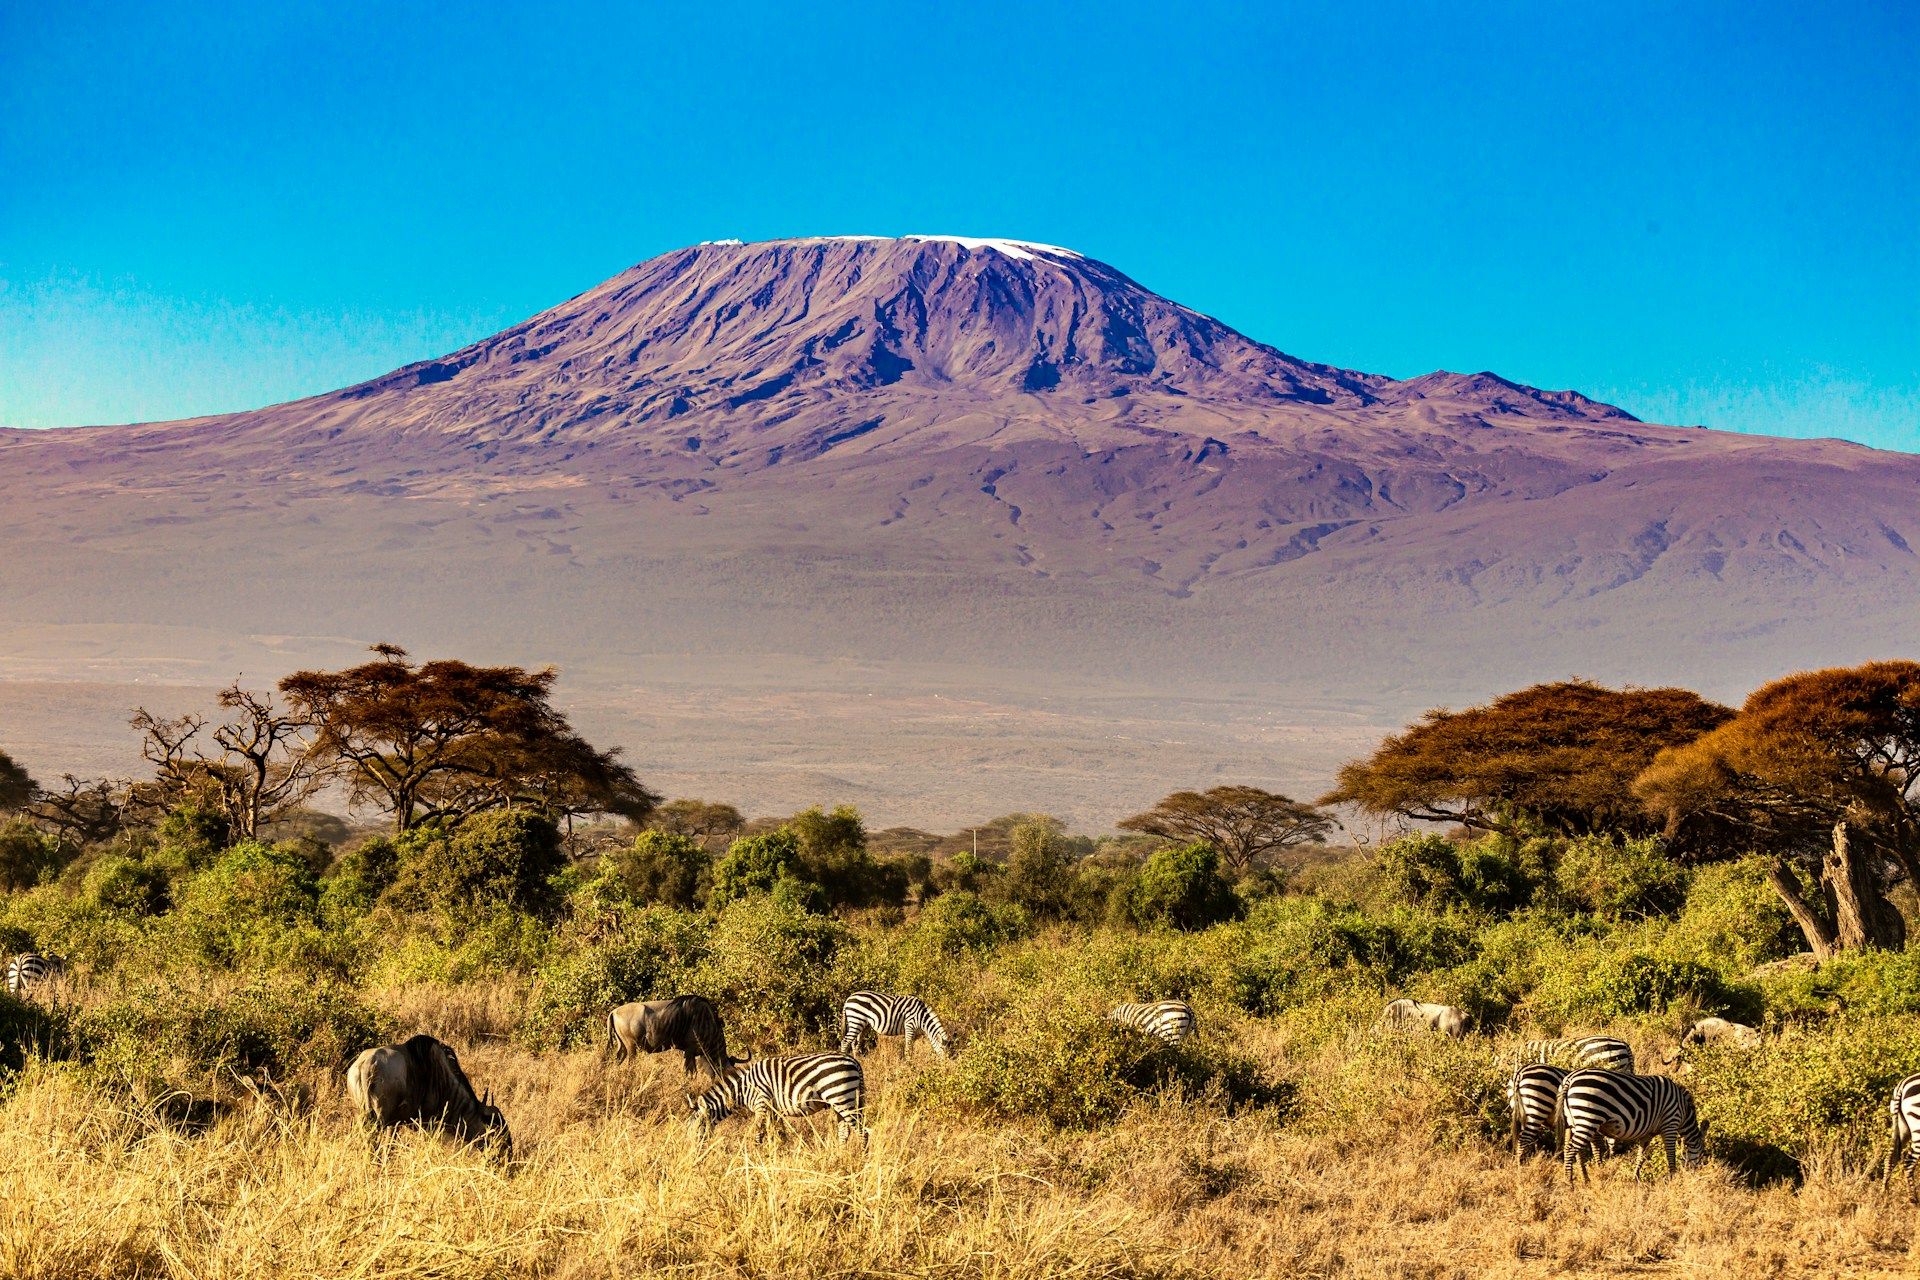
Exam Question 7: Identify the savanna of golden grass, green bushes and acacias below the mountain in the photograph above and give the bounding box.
[0,667,1920,1280]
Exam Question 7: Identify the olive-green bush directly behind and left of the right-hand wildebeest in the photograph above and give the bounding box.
[518,908,707,1050]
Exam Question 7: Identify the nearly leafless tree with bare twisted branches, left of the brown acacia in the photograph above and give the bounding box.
[132,683,326,839]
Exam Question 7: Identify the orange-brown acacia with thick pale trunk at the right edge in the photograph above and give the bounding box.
[1634,662,1920,958]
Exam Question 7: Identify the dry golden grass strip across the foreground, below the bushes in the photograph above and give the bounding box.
[0,1013,1920,1280]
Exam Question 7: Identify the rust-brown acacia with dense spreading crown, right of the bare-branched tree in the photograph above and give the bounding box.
[280,645,659,831]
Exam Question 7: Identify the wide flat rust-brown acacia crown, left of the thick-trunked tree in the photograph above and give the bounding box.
[1319,679,1734,835]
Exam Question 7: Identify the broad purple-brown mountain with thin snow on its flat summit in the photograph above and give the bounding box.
[0,236,1920,821]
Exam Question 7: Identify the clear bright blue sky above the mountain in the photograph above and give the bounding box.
[0,0,1920,449]
